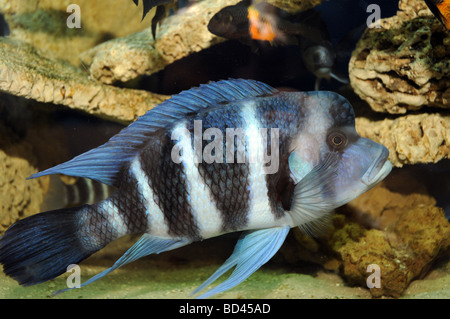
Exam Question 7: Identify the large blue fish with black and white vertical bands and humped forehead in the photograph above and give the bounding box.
[0,79,391,297]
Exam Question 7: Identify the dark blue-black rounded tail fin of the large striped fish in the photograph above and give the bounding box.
[0,206,96,286]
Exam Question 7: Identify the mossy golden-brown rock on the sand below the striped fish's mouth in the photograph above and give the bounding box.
[281,171,450,297]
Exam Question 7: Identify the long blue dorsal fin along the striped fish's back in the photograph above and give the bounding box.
[29,79,276,186]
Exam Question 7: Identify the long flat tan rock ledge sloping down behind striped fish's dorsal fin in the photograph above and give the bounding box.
[0,38,167,123]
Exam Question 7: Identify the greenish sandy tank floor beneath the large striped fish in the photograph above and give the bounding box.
[0,236,450,299]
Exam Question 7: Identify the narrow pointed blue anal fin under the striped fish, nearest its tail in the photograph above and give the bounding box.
[53,234,191,295]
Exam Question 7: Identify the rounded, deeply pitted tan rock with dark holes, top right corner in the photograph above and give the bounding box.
[349,0,450,114]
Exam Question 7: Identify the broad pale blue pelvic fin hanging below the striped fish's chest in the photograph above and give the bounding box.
[192,226,290,298]
